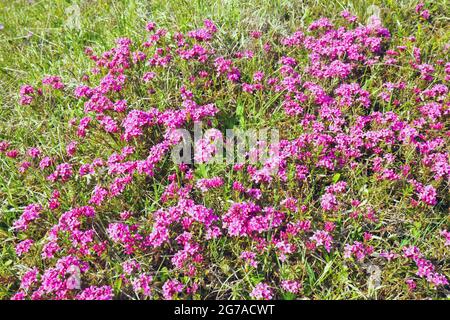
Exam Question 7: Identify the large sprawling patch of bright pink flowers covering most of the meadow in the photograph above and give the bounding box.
[5,10,450,300]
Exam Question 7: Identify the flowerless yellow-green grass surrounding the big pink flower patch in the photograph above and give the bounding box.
[0,0,450,299]
